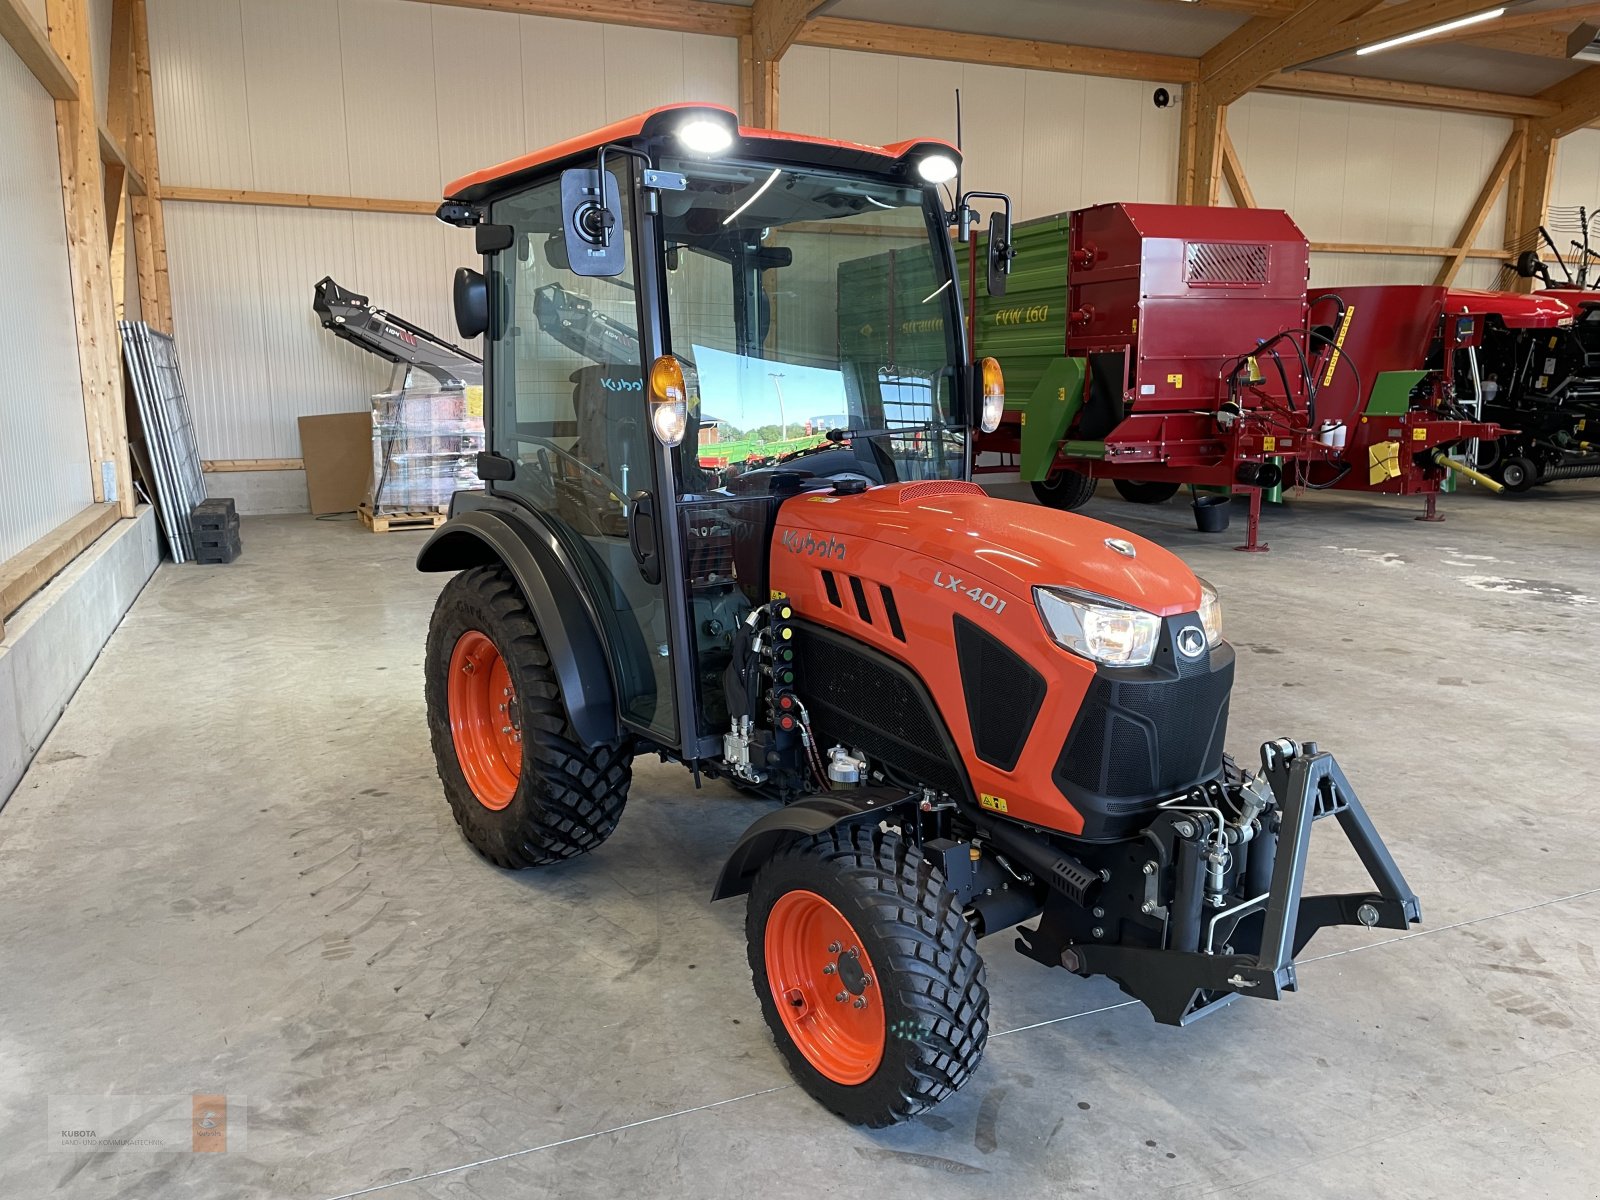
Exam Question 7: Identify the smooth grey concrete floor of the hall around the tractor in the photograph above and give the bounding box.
[0,485,1600,1200]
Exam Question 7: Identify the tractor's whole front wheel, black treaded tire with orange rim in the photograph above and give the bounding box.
[746,826,989,1128]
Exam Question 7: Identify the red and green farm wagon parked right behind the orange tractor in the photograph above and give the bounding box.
[970,203,1499,549]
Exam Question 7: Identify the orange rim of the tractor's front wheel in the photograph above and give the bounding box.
[766,890,886,1085]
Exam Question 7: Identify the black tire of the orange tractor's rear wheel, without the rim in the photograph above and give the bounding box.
[426,565,634,870]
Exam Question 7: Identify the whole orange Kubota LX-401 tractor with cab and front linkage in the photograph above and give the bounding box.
[418,106,1419,1125]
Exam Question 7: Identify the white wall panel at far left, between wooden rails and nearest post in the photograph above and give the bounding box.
[0,42,94,560]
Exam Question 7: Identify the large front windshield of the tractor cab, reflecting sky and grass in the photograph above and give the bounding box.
[661,160,966,493]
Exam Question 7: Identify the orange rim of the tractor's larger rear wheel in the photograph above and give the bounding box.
[445,629,522,811]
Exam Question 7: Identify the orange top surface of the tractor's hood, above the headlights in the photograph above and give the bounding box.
[774,480,1200,616]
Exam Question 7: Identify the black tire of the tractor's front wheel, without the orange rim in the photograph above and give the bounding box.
[746,826,989,1128]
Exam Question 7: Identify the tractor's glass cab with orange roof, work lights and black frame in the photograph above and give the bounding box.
[442,106,998,760]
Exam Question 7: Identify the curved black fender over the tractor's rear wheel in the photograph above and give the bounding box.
[416,507,622,746]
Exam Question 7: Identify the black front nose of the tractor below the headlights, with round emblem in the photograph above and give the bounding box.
[1054,618,1234,837]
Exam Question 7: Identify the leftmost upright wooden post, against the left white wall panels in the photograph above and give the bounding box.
[45,0,136,517]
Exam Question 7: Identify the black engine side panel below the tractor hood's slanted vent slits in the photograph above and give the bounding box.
[795,622,966,795]
